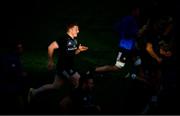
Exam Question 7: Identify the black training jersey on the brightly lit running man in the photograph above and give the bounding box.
[57,34,78,70]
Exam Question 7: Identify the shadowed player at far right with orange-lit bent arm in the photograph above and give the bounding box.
[142,17,175,113]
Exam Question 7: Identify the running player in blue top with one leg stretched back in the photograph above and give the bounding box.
[91,6,141,78]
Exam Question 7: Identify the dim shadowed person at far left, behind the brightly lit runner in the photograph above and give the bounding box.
[0,34,27,113]
